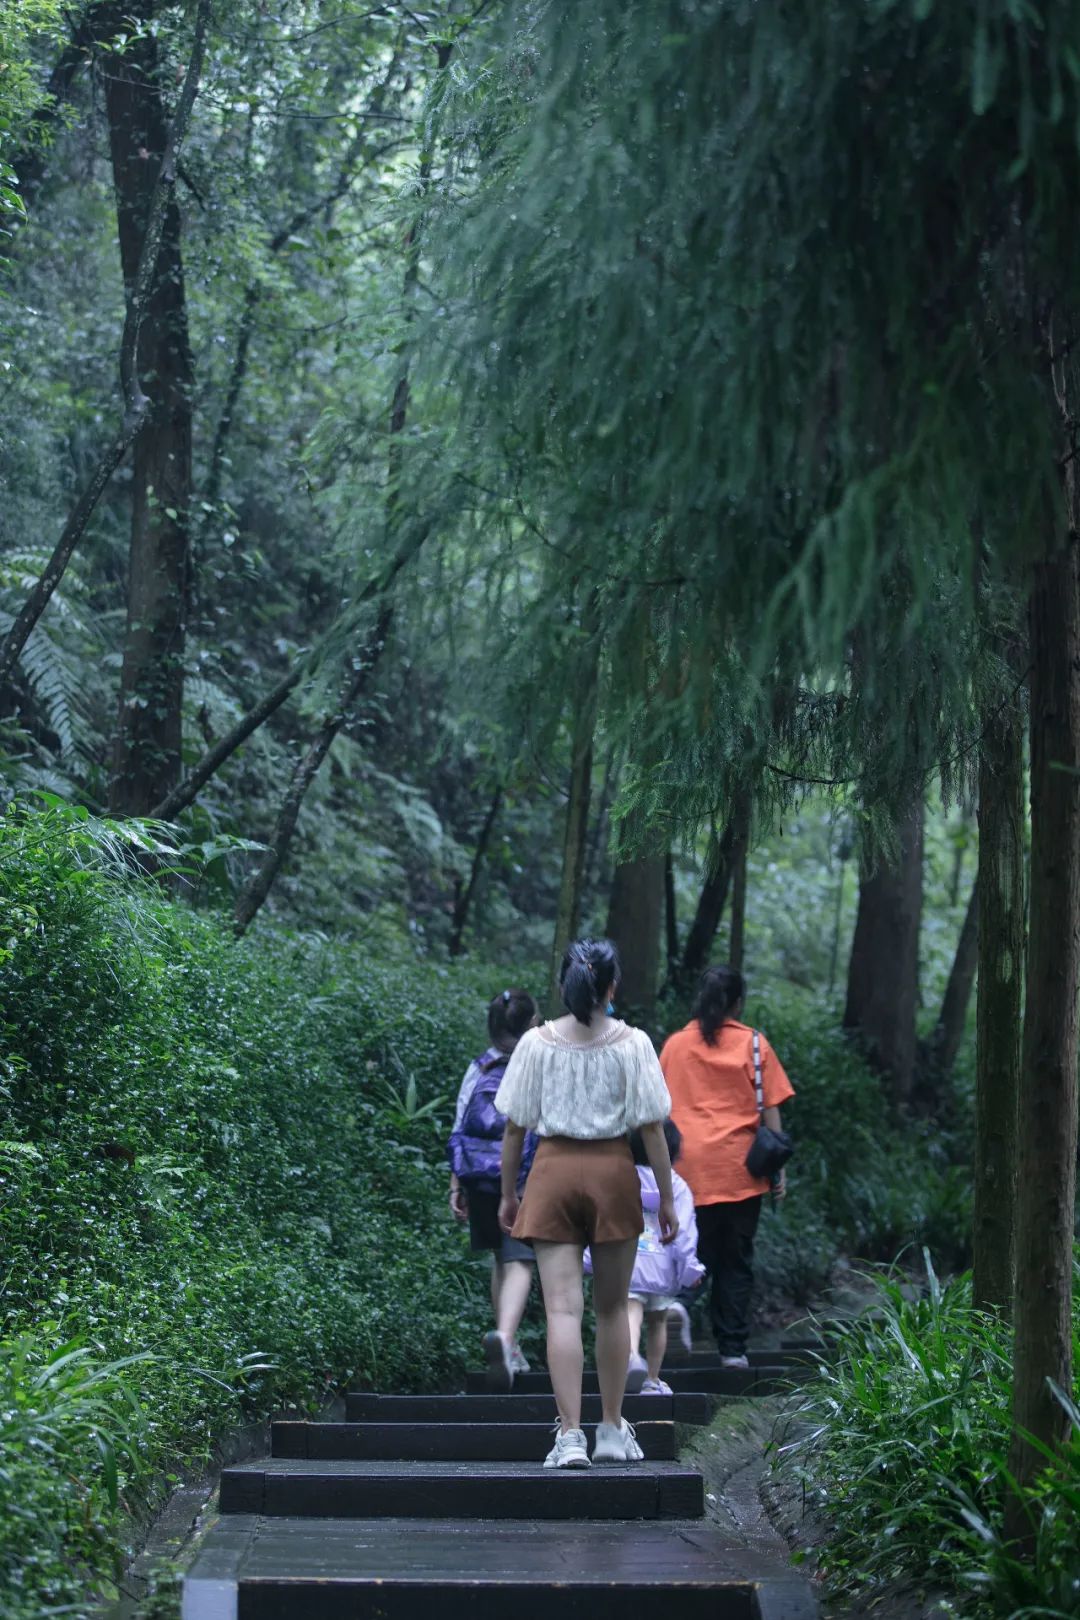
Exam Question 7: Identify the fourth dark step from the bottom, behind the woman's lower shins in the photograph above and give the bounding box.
[345,1392,716,1424]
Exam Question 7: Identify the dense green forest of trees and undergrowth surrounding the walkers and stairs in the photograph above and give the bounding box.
[0,0,1080,1615]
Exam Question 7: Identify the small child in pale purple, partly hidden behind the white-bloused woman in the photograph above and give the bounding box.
[627,1119,704,1395]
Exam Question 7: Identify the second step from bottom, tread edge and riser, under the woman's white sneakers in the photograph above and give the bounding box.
[220,1458,704,1520]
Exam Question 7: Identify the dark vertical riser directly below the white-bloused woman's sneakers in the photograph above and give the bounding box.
[220,1468,704,1520]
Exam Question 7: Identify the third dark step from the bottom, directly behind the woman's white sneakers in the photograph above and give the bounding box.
[270,1419,675,1463]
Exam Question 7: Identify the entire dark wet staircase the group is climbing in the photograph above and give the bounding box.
[183,1351,816,1620]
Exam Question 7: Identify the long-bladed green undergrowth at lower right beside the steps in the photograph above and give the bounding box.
[776,1256,1080,1620]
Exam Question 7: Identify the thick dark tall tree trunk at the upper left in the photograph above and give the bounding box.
[104,15,194,815]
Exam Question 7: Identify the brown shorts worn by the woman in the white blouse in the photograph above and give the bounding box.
[513,1136,644,1247]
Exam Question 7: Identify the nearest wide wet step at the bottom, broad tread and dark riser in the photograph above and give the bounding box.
[183,1515,818,1620]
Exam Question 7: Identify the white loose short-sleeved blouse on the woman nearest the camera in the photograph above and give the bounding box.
[495,1019,672,1142]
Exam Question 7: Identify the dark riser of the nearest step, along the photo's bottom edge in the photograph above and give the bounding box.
[236,1581,757,1620]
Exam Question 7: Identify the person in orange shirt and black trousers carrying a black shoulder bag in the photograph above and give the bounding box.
[661,967,795,1367]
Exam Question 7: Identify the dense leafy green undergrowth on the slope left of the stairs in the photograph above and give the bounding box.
[0,810,491,1620]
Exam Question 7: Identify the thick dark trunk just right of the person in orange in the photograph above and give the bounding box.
[844,800,923,1106]
